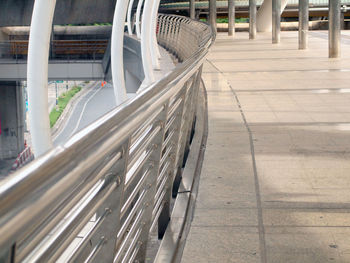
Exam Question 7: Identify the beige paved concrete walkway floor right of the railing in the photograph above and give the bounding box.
[182,32,350,263]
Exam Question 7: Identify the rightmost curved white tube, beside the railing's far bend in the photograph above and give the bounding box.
[150,0,160,70]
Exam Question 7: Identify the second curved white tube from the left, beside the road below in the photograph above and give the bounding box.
[111,0,129,106]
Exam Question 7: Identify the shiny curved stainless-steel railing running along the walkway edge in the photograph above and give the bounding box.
[0,15,215,262]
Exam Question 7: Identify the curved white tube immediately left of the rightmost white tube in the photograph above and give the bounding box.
[141,0,154,86]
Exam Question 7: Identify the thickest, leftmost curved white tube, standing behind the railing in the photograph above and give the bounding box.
[27,0,56,157]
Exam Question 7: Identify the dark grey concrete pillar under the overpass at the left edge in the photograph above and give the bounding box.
[0,81,25,160]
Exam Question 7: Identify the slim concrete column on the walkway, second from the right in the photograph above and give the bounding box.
[299,0,309,49]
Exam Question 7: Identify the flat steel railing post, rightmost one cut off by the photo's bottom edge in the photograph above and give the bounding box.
[135,102,169,262]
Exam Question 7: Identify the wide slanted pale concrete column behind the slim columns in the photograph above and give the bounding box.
[256,0,288,32]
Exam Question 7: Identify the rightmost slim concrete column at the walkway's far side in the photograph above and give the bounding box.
[328,0,340,58]
